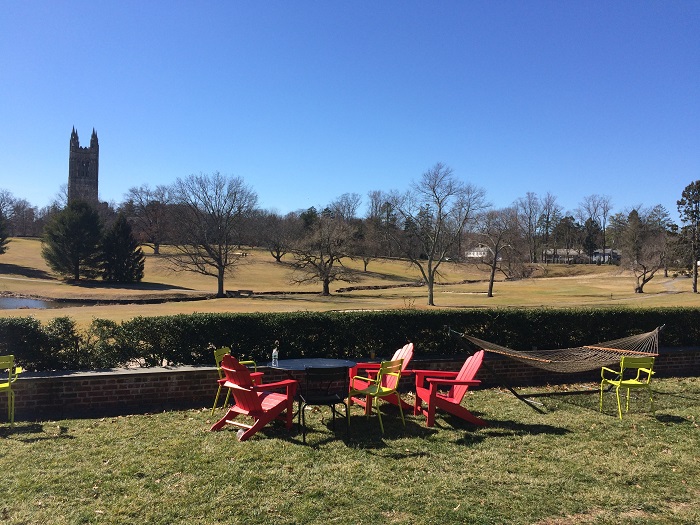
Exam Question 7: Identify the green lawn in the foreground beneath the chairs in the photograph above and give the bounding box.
[0,378,700,525]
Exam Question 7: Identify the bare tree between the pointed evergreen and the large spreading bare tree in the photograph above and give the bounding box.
[125,184,172,255]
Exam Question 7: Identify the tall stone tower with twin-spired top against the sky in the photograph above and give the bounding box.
[68,127,100,205]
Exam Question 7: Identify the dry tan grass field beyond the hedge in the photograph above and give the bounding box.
[0,239,700,323]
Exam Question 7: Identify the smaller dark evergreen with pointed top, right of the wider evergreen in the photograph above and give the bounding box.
[102,213,144,283]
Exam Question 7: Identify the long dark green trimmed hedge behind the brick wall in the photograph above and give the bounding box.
[0,308,700,371]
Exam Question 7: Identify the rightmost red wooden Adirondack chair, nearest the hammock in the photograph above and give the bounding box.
[413,350,486,427]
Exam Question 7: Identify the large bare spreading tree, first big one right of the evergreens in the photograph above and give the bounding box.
[168,172,258,297]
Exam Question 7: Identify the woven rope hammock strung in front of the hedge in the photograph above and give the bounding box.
[462,326,663,373]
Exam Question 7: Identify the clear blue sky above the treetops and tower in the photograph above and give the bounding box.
[0,0,700,218]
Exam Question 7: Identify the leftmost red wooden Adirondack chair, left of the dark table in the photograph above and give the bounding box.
[211,354,297,441]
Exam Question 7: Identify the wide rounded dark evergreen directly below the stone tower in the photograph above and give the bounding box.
[41,201,102,281]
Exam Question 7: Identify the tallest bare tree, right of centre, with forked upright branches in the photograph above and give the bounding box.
[394,163,486,306]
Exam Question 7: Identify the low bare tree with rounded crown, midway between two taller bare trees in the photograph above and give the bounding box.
[292,213,356,296]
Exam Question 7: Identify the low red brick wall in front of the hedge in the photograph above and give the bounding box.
[0,348,700,422]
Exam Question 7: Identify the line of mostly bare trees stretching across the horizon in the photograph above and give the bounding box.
[0,163,700,305]
